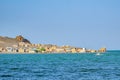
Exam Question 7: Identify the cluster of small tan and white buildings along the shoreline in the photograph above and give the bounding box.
[0,42,106,53]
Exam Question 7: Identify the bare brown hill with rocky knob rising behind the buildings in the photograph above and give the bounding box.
[0,35,30,47]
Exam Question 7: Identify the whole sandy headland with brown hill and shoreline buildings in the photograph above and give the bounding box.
[0,35,106,53]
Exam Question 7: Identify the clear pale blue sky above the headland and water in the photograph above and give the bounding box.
[0,0,120,50]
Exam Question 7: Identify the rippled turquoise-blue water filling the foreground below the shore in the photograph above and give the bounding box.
[0,51,120,80]
